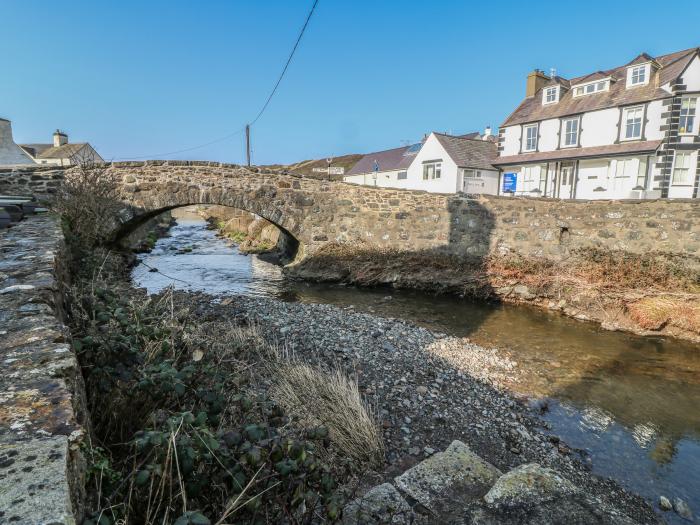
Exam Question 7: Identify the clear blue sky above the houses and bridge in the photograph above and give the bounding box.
[0,0,700,164]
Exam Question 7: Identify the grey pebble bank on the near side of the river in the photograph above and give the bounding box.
[178,294,659,523]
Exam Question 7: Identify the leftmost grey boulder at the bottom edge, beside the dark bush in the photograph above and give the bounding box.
[341,483,414,525]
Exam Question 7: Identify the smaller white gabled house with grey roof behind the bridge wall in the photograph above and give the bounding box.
[343,132,498,195]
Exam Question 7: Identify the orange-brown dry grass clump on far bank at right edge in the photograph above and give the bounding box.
[627,296,700,333]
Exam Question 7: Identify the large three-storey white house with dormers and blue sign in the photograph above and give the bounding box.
[494,48,700,199]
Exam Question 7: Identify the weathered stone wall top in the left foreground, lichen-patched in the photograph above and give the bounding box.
[0,215,88,524]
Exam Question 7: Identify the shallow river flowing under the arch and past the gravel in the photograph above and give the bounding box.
[132,213,700,523]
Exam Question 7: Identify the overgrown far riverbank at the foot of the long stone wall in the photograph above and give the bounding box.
[285,244,700,342]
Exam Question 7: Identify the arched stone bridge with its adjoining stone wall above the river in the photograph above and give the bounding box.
[0,161,700,259]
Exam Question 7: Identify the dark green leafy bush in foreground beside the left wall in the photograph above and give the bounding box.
[72,285,341,525]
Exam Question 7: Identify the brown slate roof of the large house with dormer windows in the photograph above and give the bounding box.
[501,47,700,127]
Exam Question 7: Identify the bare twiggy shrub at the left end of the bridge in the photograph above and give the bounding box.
[53,161,123,247]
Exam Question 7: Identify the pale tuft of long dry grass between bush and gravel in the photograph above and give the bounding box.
[271,361,384,467]
